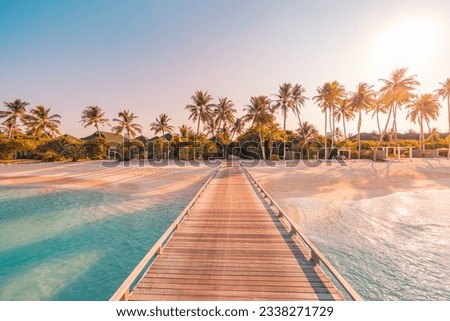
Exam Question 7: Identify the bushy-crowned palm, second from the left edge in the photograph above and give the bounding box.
[25,105,61,137]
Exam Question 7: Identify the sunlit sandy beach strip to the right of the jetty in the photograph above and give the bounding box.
[244,159,450,201]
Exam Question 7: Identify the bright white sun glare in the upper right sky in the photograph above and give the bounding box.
[372,18,442,70]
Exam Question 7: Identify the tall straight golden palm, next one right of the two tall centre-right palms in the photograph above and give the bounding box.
[313,81,345,159]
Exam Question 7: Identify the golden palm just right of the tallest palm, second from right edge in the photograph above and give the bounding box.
[406,94,441,149]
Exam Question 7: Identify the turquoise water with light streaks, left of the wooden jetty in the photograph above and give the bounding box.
[0,187,189,300]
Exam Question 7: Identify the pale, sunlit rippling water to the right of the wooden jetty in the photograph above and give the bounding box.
[283,191,450,300]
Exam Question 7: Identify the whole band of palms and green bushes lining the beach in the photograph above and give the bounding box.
[0,68,450,161]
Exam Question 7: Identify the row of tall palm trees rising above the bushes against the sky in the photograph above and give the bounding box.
[0,68,450,159]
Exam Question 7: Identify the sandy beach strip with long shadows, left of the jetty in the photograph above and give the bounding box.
[0,161,218,201]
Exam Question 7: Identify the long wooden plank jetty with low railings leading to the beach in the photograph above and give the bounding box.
[111,164,361,301]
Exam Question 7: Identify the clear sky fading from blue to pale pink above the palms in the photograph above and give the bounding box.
[0,0,450,137]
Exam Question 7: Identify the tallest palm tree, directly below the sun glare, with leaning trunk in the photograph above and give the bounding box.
[373,68,420,160]
